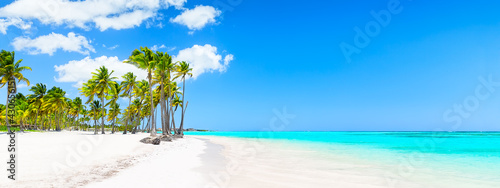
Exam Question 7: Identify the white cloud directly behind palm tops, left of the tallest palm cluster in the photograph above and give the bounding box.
[54,56,147,87]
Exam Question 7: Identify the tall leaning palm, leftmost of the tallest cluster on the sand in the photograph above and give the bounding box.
[125,47,156,136]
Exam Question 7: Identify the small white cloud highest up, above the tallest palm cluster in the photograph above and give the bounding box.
[170,5,222,33]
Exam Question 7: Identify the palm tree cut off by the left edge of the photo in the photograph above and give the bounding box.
[0,50,31,132]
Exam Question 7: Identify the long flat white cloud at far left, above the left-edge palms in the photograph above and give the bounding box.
[11,32,95,55]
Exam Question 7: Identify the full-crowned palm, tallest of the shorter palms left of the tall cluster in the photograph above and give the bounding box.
[91,66,118,134]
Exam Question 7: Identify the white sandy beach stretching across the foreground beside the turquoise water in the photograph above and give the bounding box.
[0,131,496,188]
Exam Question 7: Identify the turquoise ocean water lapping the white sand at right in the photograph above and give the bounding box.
[185,132,500,183]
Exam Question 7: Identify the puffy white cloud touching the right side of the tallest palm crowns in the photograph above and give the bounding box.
[173,44,234,79]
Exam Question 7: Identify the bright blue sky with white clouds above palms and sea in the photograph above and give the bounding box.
[0,0,500,131]
